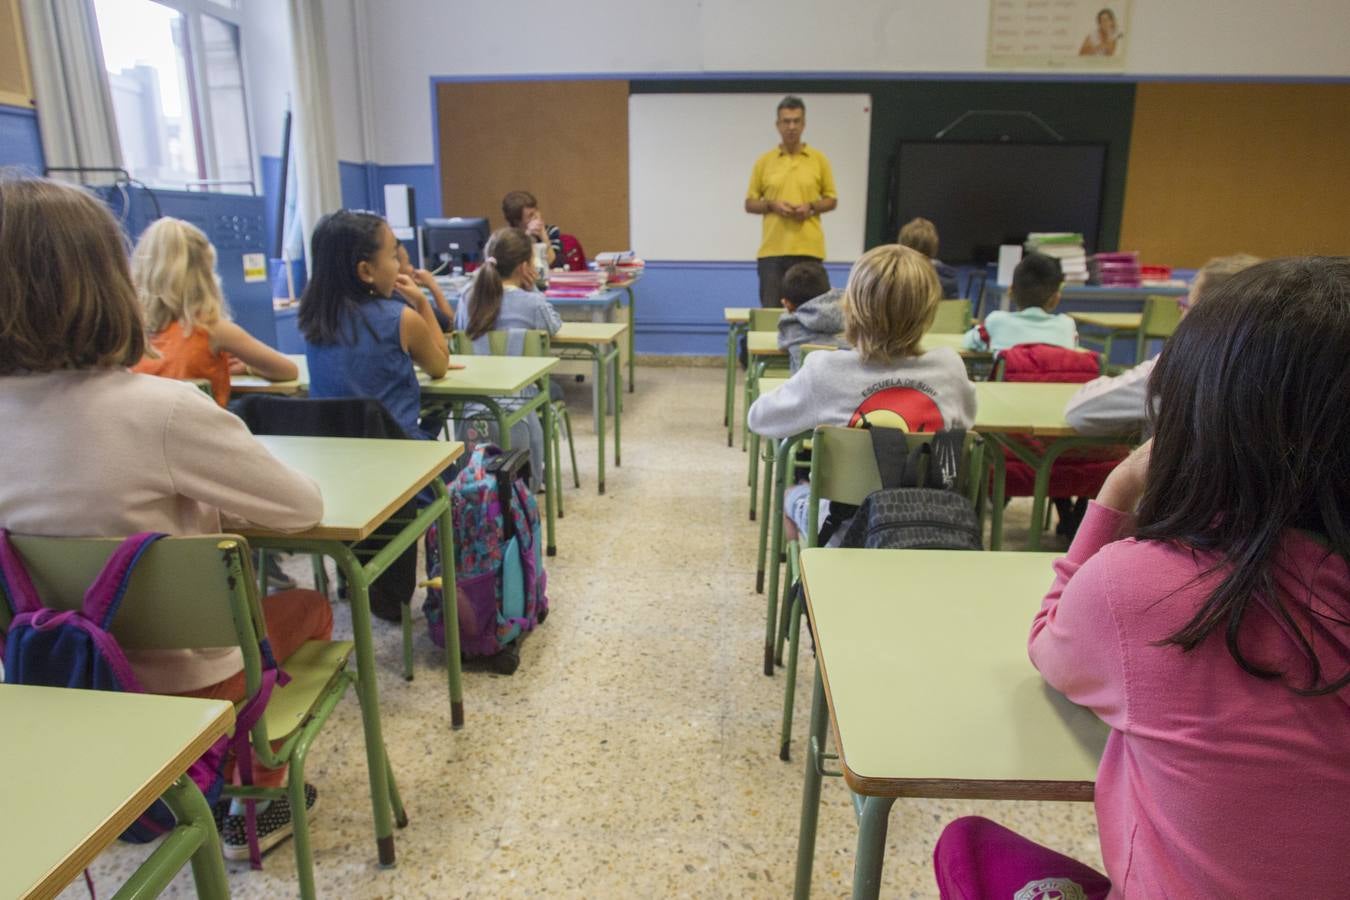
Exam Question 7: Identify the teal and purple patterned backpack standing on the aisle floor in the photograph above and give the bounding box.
[423,444,548,675]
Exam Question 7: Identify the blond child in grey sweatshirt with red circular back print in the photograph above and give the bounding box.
[748,244,975,542]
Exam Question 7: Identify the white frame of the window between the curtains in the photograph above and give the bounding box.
[103,0,258,194]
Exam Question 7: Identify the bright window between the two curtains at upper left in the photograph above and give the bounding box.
[95,0,254,192]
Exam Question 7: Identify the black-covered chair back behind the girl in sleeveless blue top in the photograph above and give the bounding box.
[231,394,408,439]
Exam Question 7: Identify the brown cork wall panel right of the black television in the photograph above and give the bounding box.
[1121,84,1350,266]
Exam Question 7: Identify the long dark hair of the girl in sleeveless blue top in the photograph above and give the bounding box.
[296,209,386,344]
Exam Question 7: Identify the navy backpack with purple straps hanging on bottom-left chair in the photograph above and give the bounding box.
[0,529,289,868]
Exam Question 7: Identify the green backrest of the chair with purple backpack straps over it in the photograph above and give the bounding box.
[0,534,257,655]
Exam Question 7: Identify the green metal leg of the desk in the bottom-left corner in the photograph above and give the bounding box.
[113,775,230,900]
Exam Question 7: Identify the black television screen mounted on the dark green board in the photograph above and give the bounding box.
[895,140,1106,263]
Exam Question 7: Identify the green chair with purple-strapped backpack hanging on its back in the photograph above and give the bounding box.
[0,534,386,897]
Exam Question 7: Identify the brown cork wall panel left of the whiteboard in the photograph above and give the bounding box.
[436,81,629,256]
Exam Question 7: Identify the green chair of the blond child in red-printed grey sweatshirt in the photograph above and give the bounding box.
[778,425,984,760]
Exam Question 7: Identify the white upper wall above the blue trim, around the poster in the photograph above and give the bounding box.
[244,0,1350,165]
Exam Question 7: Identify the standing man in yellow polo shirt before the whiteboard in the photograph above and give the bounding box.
[745,97,838,306]
